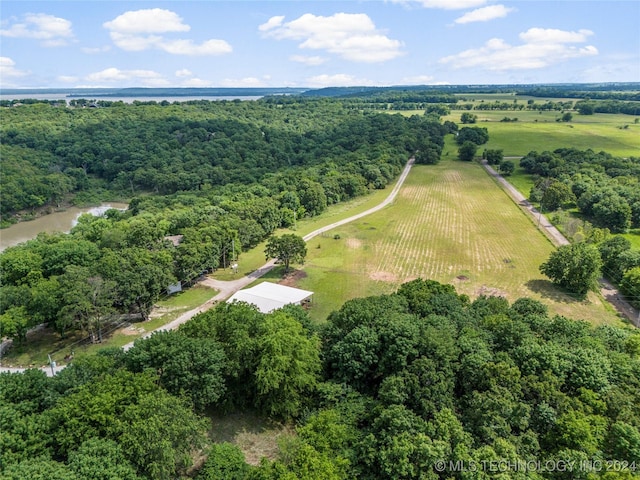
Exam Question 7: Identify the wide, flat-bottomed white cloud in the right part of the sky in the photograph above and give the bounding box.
[440,28,598,71]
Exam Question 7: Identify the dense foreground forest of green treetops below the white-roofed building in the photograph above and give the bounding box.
[0,279,640,480]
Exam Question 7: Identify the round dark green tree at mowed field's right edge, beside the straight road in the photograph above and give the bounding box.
[540,243,602,297]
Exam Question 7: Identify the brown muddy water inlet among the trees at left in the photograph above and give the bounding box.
[0,202,127,251]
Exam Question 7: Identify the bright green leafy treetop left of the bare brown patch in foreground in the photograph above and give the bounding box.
[46,370,205,480]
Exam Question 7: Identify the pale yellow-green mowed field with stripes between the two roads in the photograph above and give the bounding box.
[296,160,620,324]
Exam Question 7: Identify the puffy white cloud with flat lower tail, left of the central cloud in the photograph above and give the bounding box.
[102,8,233,56]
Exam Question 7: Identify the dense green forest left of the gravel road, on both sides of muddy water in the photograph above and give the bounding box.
[0,97,446,342]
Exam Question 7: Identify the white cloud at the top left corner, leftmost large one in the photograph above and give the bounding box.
[0,13,73,47]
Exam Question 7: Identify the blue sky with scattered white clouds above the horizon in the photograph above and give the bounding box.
[0,0,640,88]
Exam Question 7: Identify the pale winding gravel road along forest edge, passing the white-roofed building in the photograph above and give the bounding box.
[0,157,415,376]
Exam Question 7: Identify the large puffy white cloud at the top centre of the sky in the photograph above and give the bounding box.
[259,13,403,63]
